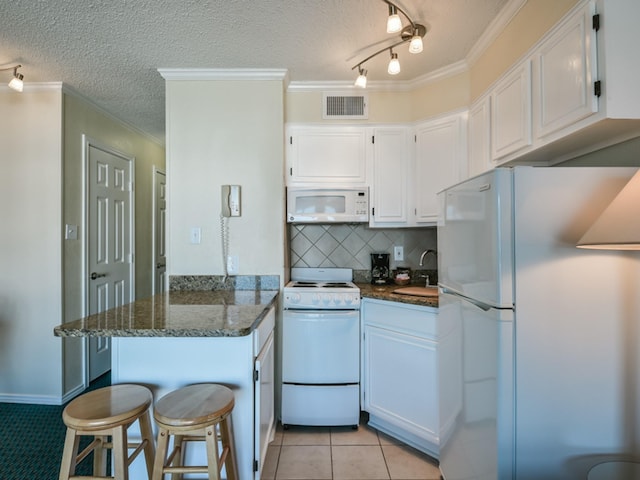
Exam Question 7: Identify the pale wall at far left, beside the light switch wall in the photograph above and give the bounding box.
[0,86,62,403]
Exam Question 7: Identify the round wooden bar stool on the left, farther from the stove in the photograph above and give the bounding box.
[59,385,155,480]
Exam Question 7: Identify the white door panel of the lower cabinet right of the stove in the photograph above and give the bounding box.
[363,325,438,444]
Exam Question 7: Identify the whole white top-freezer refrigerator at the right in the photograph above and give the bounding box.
[438,167,640,480]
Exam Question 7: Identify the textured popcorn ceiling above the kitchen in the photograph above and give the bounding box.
[0,0,508,140]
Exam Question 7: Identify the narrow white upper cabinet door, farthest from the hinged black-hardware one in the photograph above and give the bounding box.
[467,96,494,177]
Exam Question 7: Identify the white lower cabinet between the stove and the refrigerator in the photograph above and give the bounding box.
[361,299,439,457]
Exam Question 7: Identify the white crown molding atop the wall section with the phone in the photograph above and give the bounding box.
[158,68,289,81]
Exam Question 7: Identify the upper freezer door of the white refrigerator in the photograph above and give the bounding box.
[438,169,513,308]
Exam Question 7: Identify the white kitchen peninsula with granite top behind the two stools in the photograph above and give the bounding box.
[54,282,278,480]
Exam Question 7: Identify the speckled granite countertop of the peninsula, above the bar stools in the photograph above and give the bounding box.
[54,290,278,337]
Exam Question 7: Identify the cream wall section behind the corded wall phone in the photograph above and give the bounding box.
[166,79,285,278]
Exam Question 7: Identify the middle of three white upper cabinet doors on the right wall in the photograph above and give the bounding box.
[491,60,531,160]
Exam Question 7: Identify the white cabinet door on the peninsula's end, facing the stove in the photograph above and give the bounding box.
[254,331,276,478]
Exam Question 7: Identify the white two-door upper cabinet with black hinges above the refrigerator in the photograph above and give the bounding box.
[490,0,640,165]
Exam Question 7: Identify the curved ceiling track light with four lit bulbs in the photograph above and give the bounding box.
[351,0,427,88]
